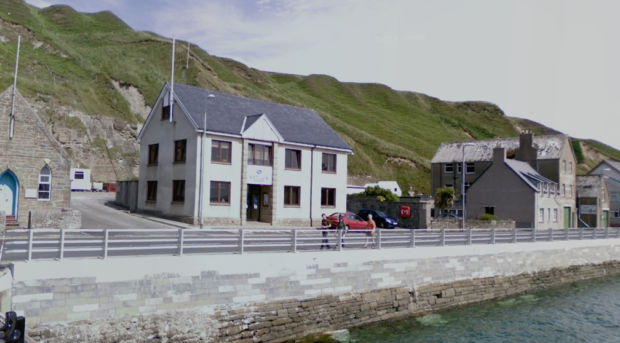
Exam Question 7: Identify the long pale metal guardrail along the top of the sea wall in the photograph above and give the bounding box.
[0,228,620,261]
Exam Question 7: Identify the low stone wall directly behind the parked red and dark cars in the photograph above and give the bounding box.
[347,196,435,228]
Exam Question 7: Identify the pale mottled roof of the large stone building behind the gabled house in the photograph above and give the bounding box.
[431,134,566,163]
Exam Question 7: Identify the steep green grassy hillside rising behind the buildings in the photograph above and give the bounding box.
[0,0,620,193]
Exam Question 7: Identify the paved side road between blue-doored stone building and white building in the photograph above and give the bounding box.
[71,192,187,229]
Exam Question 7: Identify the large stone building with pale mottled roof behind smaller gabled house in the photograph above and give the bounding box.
[431,132,577,227]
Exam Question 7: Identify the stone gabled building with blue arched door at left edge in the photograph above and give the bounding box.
[0,87,71,226]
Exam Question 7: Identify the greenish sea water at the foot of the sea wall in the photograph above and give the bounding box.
[338,277,620,343]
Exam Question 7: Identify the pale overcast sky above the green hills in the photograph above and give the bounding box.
[26,0,620,149]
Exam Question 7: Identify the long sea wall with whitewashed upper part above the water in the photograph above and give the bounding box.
[12,239,620,342]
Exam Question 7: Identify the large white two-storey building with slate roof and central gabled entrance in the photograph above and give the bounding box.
[138,84,352,226]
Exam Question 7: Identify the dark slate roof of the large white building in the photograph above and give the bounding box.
[170,84,351,150]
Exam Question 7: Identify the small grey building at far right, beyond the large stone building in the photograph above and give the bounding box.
[577,175,610,228]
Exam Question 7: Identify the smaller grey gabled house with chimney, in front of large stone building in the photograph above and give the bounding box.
[466,147,562,229]
